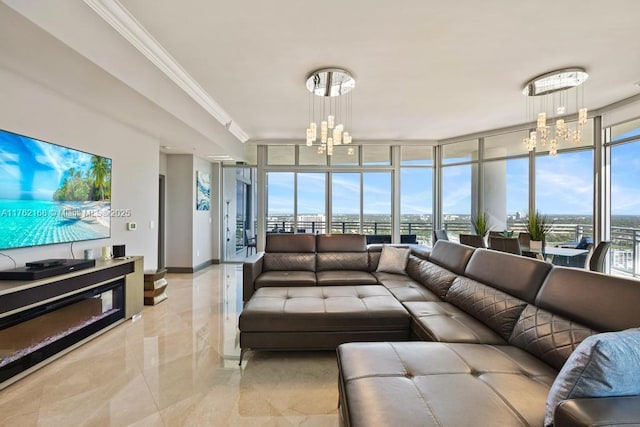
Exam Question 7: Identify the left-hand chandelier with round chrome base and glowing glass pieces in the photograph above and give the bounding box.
[306,68,356,156]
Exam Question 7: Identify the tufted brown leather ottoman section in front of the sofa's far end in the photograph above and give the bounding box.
[239,285,411,363]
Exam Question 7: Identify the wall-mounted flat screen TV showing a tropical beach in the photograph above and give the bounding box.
[0,130,111,249]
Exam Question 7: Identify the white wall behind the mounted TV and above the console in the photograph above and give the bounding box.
[0,66,159,270]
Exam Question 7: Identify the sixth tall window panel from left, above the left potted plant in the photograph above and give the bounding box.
[442,139,478,241]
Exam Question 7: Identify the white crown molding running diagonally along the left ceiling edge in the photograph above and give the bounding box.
[84,0,249,143]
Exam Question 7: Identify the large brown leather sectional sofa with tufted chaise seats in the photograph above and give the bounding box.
[240,235,640,426]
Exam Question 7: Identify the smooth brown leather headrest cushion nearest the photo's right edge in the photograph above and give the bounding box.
[536,267,640,332]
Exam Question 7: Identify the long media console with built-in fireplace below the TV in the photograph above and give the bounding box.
[0,257,144,389]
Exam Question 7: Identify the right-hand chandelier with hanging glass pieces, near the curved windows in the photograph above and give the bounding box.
[522,67,589,156]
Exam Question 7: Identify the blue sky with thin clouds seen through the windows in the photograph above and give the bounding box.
[268,125,640,215]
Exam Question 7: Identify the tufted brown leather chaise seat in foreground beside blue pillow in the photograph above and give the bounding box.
[337,342,556,427]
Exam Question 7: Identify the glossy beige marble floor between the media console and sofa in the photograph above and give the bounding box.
[0,264,338,427]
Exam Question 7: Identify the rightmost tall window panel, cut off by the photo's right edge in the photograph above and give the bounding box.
[608,119,640,277]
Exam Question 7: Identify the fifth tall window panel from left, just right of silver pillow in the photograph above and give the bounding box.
[400,146,433,245]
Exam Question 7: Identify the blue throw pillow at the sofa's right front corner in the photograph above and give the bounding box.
[544,328,640,426]
